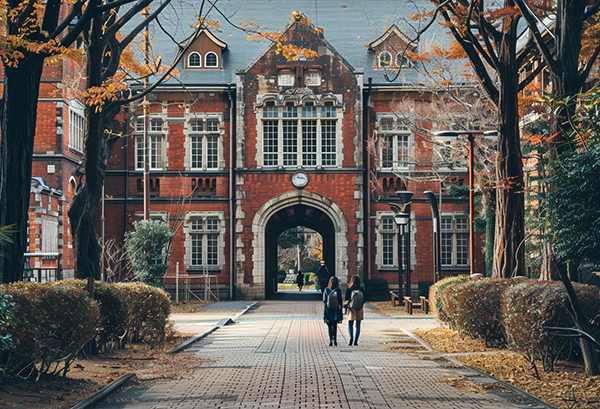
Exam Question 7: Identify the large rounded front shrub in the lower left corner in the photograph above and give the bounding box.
[2,281,99,376]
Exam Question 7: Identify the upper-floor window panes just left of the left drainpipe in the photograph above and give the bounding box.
[189,118,220,169]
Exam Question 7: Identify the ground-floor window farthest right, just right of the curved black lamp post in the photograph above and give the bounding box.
[441,215,469,267]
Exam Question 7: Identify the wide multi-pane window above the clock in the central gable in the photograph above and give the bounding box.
[259,101,339,167]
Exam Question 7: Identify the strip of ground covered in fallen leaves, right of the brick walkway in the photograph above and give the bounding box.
[371,302,600,409]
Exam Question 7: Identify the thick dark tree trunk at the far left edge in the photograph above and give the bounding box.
[0,53,44,283]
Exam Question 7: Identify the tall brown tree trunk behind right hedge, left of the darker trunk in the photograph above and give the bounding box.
[492,14,525,278]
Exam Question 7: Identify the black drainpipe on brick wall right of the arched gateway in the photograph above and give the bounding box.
[363,77,373,281]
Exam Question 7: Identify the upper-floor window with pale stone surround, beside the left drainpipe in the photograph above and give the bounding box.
[184,114,225,171]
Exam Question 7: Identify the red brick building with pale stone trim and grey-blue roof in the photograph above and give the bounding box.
[22,1,483,299]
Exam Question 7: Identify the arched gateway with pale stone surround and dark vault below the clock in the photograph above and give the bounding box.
[237,190,348,297]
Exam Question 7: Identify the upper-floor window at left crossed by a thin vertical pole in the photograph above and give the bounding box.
[135,118,167,170]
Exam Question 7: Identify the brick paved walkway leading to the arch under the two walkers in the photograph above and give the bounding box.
[100,298,552,409]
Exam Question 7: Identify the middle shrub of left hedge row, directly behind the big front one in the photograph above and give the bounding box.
[67,280,129,350]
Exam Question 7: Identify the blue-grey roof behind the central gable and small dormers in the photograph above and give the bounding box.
[144,0,454,88]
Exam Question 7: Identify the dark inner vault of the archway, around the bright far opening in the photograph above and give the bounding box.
[265,204,336,298]
